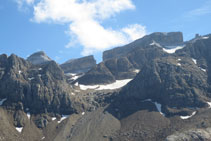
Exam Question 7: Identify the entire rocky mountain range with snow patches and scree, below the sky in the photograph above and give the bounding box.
[0,32,211,141]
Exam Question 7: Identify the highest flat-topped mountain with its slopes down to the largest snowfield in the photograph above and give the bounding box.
[78,32,184,84]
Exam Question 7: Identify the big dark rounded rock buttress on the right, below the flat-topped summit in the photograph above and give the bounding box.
[120,57,211,110]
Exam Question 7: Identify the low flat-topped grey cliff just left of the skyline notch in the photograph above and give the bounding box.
[60,55,96,73]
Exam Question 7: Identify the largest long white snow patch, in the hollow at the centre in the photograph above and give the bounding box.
[79,79,132,90]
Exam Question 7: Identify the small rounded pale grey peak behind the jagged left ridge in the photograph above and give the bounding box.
[27,51,51,65]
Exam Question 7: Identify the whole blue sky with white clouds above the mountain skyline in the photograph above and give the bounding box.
[0,0,211,63]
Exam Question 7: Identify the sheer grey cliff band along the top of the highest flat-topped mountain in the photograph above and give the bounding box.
[103,32,183,61]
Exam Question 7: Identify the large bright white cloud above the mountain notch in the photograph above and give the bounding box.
[16,0,146,55]
